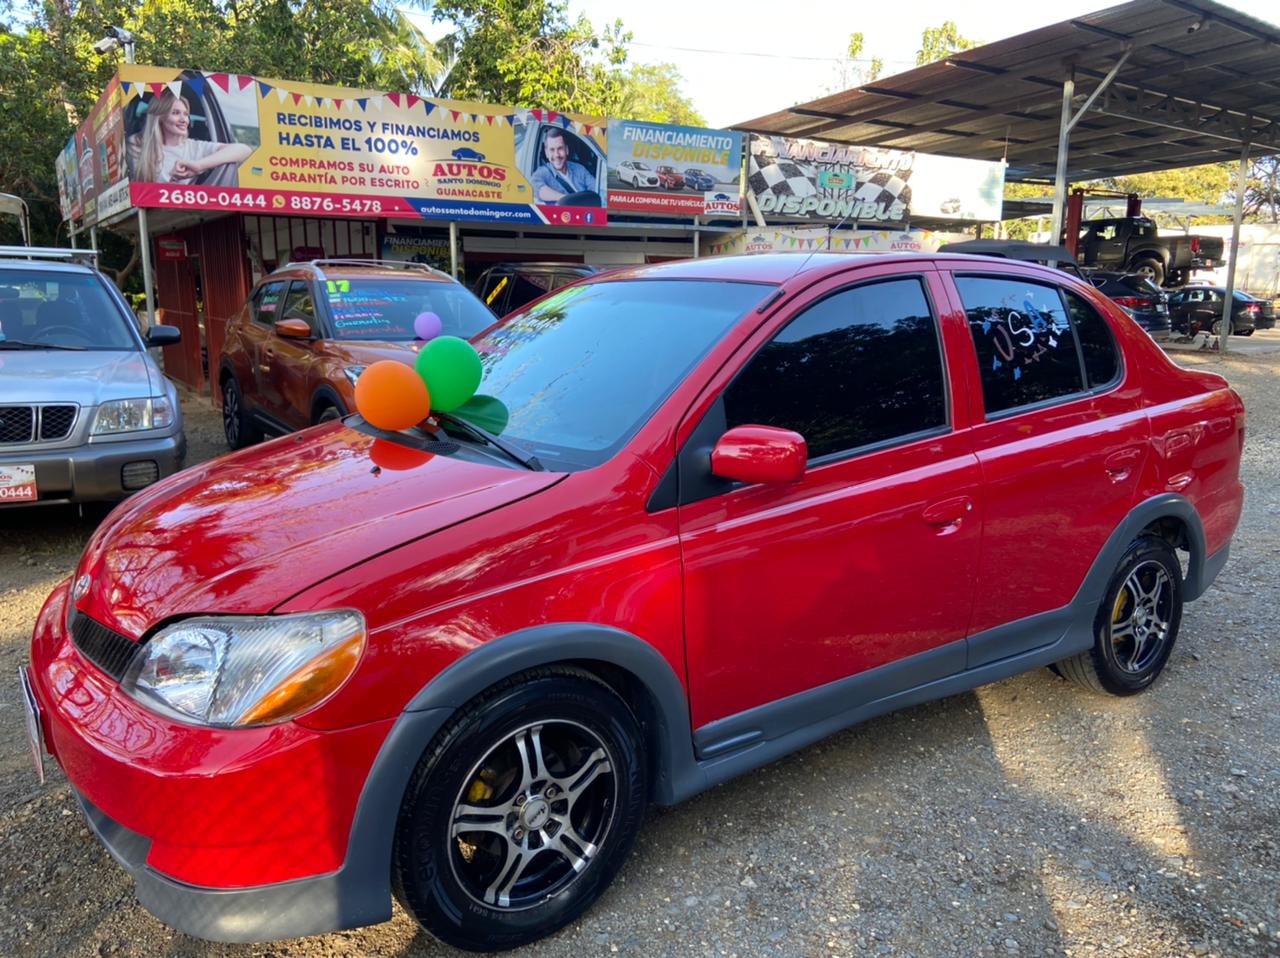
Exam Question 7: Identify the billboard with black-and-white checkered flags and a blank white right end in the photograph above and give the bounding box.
[748,134,1005,223]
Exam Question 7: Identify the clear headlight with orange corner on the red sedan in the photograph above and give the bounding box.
[120,610,365,727]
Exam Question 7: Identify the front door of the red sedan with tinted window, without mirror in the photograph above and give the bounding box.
[678,266,982,737]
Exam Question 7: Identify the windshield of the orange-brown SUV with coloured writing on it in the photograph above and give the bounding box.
[321,277,493,342]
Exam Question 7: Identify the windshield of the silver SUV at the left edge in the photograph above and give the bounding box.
[0,268,141,350]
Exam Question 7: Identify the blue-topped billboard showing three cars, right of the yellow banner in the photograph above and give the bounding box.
[609,119,742,216]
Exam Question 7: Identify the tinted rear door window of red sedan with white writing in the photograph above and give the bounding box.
[956,277,1084,415]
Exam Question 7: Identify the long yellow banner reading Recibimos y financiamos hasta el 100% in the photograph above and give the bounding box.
[82,65,607,225]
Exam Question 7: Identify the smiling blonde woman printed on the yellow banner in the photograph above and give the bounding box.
[129,90,253,186]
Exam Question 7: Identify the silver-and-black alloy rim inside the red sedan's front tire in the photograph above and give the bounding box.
[449,720,617,911]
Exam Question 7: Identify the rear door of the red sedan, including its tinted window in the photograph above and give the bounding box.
[952,269,1149,667]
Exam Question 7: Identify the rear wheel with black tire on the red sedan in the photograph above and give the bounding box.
[1055,535,1183,695]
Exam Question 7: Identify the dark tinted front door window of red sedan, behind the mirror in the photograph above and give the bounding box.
[724,279,946,459]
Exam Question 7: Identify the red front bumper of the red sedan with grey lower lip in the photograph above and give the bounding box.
[28,581,393,941]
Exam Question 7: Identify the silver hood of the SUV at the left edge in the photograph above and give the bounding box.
[0,350,160,406]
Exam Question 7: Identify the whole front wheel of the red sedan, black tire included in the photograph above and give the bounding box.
[392,669,648,952]
